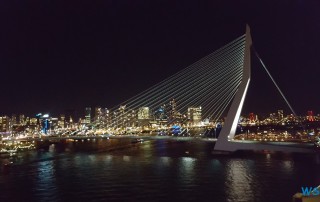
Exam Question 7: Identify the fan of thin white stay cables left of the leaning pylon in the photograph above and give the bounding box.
[91,32,249,128]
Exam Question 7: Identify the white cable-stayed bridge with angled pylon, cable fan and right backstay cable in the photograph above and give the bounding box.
[85,26,312,151]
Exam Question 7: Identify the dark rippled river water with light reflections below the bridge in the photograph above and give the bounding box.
[0,139,320,202]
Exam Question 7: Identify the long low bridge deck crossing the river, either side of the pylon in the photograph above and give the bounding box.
[2,135,316,153]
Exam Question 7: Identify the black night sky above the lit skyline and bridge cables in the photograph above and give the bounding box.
[0,0,320,115]
